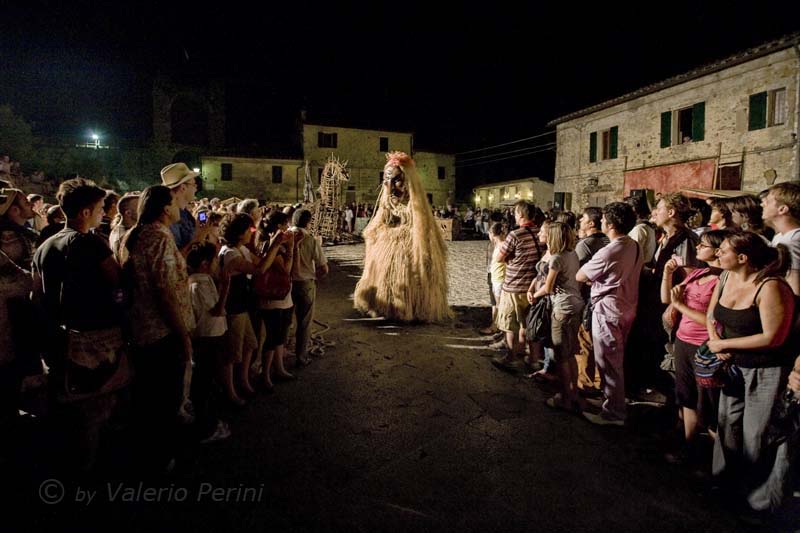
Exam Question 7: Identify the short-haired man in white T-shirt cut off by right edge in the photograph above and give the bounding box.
[761,182,800,296]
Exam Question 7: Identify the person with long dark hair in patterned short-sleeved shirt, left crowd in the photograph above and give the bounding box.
[121,185,195,471]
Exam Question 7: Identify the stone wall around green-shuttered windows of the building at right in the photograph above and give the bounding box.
[555,49,800,209]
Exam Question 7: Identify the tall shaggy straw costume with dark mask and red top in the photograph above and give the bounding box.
[354,152,452,322]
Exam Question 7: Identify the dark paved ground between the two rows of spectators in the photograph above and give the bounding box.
[7,241,800,531]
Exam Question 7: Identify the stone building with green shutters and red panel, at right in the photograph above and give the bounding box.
[548,33,800,210]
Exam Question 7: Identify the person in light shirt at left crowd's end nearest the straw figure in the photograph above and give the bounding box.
[291,209,328,366]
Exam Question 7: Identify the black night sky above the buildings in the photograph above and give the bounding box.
[0,1,800,186]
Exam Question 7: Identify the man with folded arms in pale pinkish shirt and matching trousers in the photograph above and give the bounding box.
[575,202,642,426]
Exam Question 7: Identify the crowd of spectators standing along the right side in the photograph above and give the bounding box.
[476,182,800,513]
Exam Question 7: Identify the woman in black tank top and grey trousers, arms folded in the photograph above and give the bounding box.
[707,231,794,511]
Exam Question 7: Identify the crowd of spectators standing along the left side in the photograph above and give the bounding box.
[0,163,328,474]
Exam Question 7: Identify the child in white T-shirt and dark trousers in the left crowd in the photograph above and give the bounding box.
[184,242,231,442]
